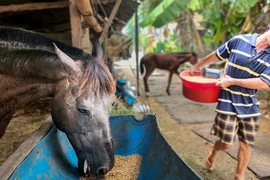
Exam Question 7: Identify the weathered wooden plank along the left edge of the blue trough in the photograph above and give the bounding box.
[0,117,53,180]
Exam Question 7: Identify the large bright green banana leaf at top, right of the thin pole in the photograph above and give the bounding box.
[139,0,189,28]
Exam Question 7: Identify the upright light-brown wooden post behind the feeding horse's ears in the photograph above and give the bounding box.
[69,0,83,49]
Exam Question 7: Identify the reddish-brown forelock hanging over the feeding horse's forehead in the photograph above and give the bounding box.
[78,61,115,96]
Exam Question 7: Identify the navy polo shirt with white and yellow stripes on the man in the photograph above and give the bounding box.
[215,34,270,118]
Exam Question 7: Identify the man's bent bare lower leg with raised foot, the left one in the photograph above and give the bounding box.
[205,140,232,171]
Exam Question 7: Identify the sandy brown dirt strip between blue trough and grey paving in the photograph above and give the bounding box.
[148,97,265,180]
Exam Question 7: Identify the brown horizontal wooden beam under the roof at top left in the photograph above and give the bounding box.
[0,1,69,13]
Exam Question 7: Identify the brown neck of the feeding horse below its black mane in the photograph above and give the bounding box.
[0,48,63,118]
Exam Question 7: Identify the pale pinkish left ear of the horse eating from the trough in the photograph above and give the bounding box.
[53,43,81,75]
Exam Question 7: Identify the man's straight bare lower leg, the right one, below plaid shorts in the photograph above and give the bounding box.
[234,141,251,180]
